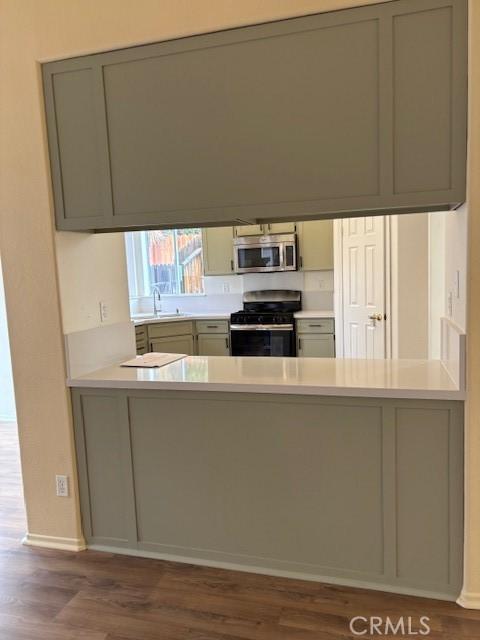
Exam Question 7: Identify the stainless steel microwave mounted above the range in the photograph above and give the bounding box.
[233,233,297,273]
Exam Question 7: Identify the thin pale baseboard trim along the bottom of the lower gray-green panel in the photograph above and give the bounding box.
[88,544,456,602]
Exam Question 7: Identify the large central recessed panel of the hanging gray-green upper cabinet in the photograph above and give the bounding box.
[104,14,379,220]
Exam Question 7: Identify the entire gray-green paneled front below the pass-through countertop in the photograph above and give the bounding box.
[73,389,463,598]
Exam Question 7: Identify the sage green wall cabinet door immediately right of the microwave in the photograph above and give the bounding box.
[299,220,333,271]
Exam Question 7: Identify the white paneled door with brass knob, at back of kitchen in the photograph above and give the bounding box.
[342,216,386,358]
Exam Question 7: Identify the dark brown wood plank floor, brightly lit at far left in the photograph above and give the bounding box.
[0,424,480,640]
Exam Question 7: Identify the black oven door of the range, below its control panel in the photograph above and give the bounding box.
[230,324,295,358]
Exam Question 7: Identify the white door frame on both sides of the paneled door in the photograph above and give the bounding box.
[333,216,396,359]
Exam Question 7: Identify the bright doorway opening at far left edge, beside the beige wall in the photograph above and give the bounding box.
[0,264,26,550]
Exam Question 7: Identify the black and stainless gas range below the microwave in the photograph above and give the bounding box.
[230,289,302,357]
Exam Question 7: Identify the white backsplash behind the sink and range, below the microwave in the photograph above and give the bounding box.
[130,271,333,314]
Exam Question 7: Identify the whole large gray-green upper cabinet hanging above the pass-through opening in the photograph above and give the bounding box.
[43,0,467,230]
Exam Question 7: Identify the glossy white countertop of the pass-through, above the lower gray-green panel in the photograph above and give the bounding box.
[68,356,464,400]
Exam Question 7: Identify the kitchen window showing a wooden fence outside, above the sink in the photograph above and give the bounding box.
[125,229,203,298]
